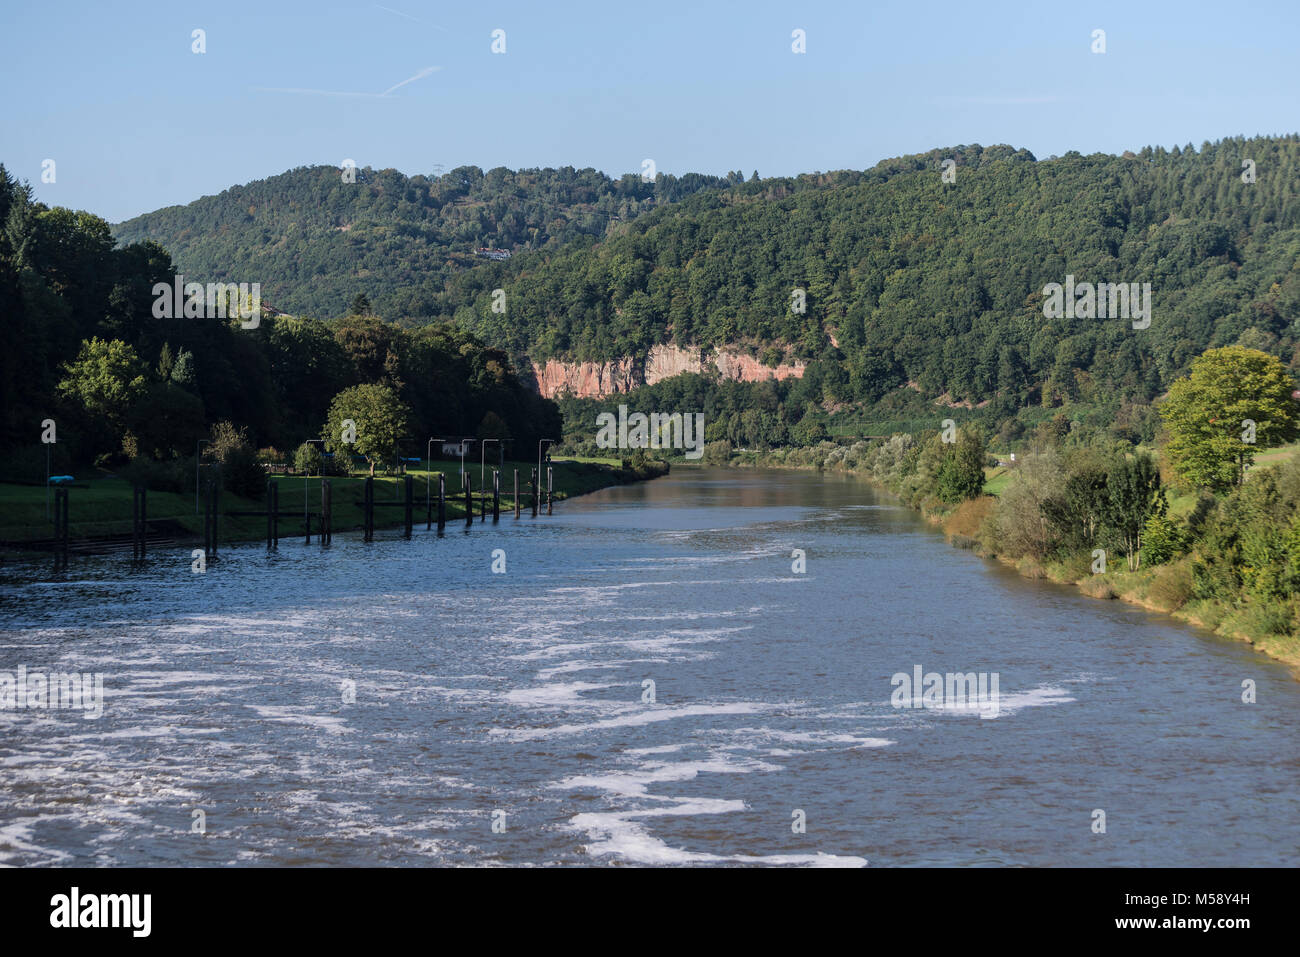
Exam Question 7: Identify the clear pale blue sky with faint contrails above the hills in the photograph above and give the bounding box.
[0,0,1300,221]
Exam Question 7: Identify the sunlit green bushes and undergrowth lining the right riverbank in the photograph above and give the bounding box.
[706,428,1300,667]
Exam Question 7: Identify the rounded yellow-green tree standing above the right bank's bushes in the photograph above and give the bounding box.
[1160,346,1300,492]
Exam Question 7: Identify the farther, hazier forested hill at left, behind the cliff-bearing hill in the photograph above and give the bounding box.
[113,166,744,320]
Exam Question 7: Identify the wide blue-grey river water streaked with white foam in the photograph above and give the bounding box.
[0,469,1300,866]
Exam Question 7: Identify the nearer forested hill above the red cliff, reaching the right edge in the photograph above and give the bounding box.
[452,135,1300,412]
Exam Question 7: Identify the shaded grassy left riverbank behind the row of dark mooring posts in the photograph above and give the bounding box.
[0,459,668,560]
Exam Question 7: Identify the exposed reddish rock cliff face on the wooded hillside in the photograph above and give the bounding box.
[533,346,805,399]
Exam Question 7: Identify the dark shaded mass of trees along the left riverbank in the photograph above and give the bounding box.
[0,166,560,481]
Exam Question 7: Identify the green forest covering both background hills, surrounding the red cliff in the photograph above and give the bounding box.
[109,135,1300,447]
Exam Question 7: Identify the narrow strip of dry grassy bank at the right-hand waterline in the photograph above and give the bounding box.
[718,447,1300,680]
